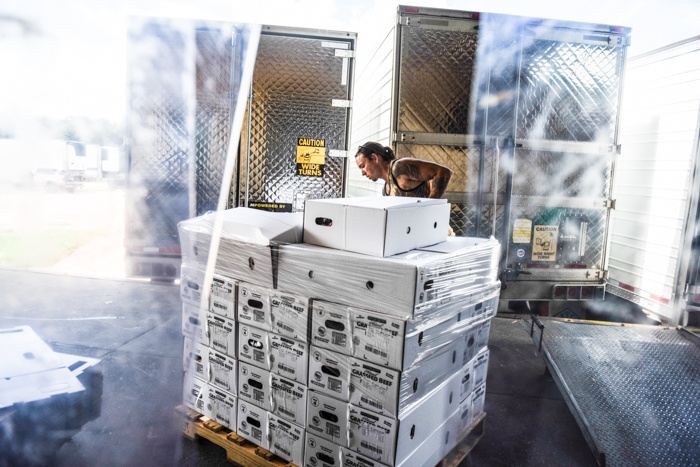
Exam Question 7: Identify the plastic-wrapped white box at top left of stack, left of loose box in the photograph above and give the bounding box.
[178,208,304,289]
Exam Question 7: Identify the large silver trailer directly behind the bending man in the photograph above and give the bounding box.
[348,6,630,308]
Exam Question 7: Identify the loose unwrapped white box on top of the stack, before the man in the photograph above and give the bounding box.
[304,196,450,257]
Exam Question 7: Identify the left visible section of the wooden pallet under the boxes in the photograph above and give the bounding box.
[175,406,296,467]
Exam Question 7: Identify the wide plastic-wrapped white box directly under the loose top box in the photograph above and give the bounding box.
[277,237,500,322]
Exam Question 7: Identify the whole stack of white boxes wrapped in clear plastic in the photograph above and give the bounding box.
[180,198,500,465]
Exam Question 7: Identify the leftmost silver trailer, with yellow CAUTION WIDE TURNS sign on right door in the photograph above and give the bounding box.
[125,18,356,280]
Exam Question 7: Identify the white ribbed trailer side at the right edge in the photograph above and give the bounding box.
[607,37,700,325]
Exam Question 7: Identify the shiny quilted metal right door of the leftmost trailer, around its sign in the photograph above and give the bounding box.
[238,34,350,206]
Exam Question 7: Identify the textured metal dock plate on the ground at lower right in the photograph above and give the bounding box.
[526,317,700,466]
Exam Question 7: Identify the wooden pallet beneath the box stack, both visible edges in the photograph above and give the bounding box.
[175,406,486,467]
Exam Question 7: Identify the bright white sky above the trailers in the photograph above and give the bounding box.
[0,0,700,128]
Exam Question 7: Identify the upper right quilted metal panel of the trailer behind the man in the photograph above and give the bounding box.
[516,34,624,144]
